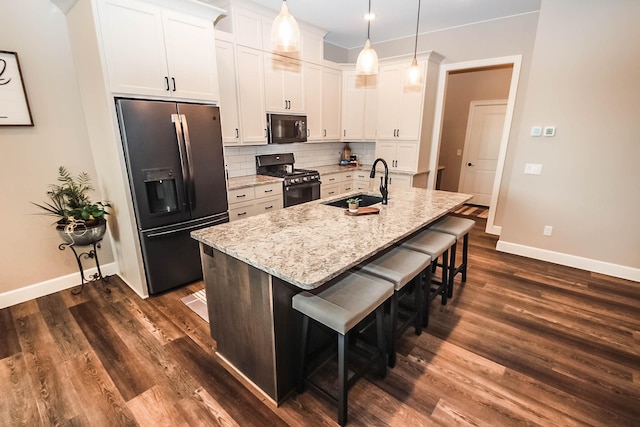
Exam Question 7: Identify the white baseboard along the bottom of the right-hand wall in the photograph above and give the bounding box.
[496,240,640,282]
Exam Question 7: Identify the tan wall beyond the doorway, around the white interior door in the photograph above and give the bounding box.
[438,67,512,191]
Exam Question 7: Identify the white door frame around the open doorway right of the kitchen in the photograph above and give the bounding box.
[427,55,522,235]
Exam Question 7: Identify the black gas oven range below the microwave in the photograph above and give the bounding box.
[256,153,321,208]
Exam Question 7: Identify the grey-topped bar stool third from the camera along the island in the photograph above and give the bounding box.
[400,230,456,327]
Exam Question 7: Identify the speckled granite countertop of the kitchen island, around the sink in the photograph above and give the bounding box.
[191,188,472,289]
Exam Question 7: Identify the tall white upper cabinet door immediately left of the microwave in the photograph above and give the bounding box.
[236,46,267,145]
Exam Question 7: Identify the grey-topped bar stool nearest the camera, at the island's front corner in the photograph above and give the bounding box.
[291,272,393,426]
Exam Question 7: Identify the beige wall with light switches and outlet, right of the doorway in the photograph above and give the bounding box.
[501,0,640,272]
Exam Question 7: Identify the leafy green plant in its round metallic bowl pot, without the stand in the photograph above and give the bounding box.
[33,166,111,246]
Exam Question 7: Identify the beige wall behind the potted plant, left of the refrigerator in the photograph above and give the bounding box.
[0,0,113,294]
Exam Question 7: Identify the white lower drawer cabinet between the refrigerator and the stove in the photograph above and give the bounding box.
[227,182,284,221]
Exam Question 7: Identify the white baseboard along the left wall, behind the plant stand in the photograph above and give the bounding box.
[0,262,118,309]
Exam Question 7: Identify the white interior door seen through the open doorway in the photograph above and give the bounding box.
[460,101,507,206]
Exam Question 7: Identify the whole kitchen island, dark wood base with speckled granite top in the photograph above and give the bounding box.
[191,188,471,403]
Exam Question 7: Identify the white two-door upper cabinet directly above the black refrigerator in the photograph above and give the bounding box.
[98,0,219,102]
